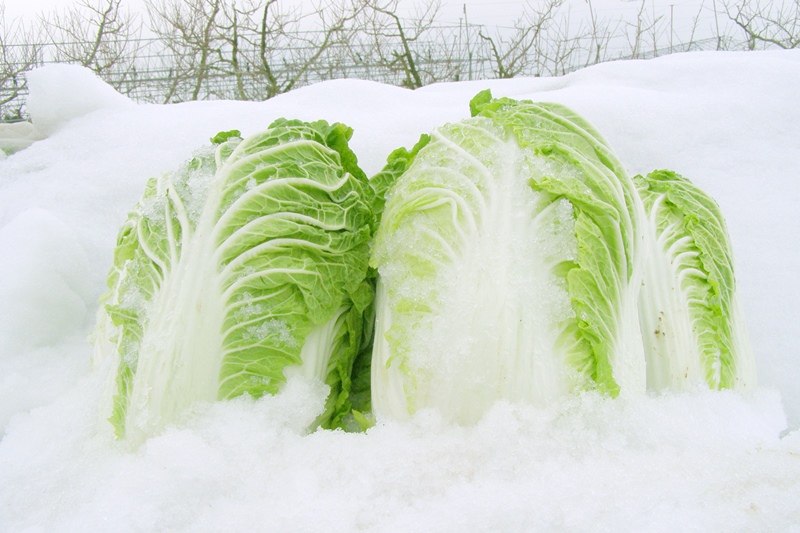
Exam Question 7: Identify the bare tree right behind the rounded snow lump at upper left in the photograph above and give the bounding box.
[41,0,141,89]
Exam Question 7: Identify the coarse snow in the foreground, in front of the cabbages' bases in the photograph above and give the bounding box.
[0,380,800,533]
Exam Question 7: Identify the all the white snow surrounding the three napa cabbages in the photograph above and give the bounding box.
[0,51,800,532]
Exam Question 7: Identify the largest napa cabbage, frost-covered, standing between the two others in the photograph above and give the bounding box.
[371,91,646,422]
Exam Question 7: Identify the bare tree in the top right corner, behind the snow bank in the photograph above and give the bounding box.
[723,0,800,50]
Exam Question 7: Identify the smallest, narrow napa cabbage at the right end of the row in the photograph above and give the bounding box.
[634,170,756,390]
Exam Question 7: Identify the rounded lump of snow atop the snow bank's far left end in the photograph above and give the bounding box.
[27,63,133,137]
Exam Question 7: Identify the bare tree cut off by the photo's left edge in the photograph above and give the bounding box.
[0,4,42,121]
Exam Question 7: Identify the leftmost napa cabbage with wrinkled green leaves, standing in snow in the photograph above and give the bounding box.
[94,119,374,438]
